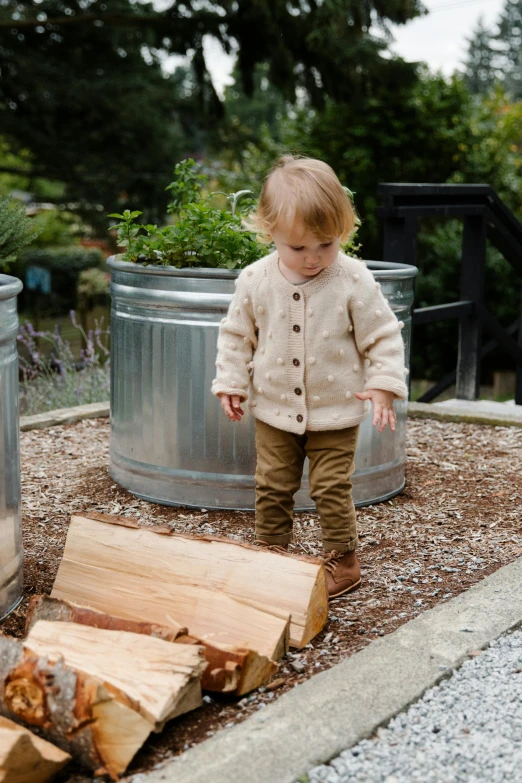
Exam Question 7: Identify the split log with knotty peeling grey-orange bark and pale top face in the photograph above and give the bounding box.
[0,621,205,780]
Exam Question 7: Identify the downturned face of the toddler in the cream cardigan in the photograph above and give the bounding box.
[271,221,340,279]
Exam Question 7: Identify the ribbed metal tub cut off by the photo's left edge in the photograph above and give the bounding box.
[0,275,23,620]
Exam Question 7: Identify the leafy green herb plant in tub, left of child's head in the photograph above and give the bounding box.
[109,158,267,269]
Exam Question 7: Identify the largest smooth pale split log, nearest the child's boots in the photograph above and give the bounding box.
[52,514,328,648]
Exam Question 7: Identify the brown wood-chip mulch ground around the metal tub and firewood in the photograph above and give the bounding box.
[2,419,522,781]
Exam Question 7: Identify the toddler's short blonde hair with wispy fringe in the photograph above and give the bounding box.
[245,155,357,242]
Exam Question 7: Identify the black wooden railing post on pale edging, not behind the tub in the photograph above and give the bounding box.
[457,215,486,400]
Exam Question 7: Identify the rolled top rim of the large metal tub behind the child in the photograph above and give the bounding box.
[107,255,419,280]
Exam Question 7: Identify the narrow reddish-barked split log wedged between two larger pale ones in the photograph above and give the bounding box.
[26,595,277,696]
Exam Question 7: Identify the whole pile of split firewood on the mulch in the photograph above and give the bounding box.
[0,514,328,783]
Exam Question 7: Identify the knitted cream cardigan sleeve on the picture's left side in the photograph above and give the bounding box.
[212,271,257,400]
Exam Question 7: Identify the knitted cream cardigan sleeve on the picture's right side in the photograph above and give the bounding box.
[350,267,408,399]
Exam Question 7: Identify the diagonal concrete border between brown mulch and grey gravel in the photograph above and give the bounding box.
[133,558,522,783]
